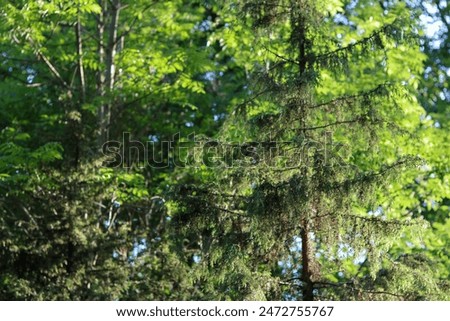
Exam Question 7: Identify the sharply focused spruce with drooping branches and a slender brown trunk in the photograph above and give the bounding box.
[175,0,446,300]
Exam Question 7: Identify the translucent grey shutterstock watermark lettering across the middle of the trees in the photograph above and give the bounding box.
[102,132,342,169]
